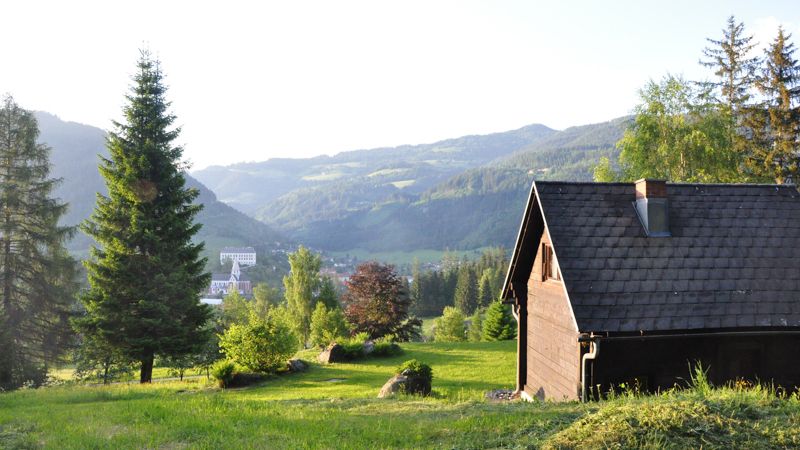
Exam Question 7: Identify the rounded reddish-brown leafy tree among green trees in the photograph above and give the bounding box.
[342,261,422,341]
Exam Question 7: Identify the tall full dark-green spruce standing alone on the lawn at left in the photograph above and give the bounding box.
[79,51,210,383]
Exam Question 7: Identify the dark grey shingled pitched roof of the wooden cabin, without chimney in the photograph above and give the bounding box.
[503,182,800,332]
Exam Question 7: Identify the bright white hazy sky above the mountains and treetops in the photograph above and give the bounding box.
[0,0,800,169]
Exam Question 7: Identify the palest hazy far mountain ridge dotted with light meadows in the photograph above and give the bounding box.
[192,125,555,216]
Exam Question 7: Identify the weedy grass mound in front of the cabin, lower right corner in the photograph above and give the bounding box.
[544,386,800,450]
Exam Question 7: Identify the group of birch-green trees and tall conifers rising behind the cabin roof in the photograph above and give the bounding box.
[594,16,800,184]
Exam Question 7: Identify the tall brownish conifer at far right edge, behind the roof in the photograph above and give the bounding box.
[748,27,800,184]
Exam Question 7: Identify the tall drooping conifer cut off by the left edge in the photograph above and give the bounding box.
[0,96,77,390]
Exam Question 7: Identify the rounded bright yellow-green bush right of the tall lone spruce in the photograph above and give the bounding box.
[219,313,297,373]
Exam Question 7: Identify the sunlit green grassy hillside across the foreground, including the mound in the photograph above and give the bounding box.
[0,341,800,449]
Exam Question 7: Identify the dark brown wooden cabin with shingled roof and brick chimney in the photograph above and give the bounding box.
[503,180,800,400]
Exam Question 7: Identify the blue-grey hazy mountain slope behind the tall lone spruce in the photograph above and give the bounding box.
[35,112,287,261]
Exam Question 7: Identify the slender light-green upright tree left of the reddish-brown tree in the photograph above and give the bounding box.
[283,245,322,345]
